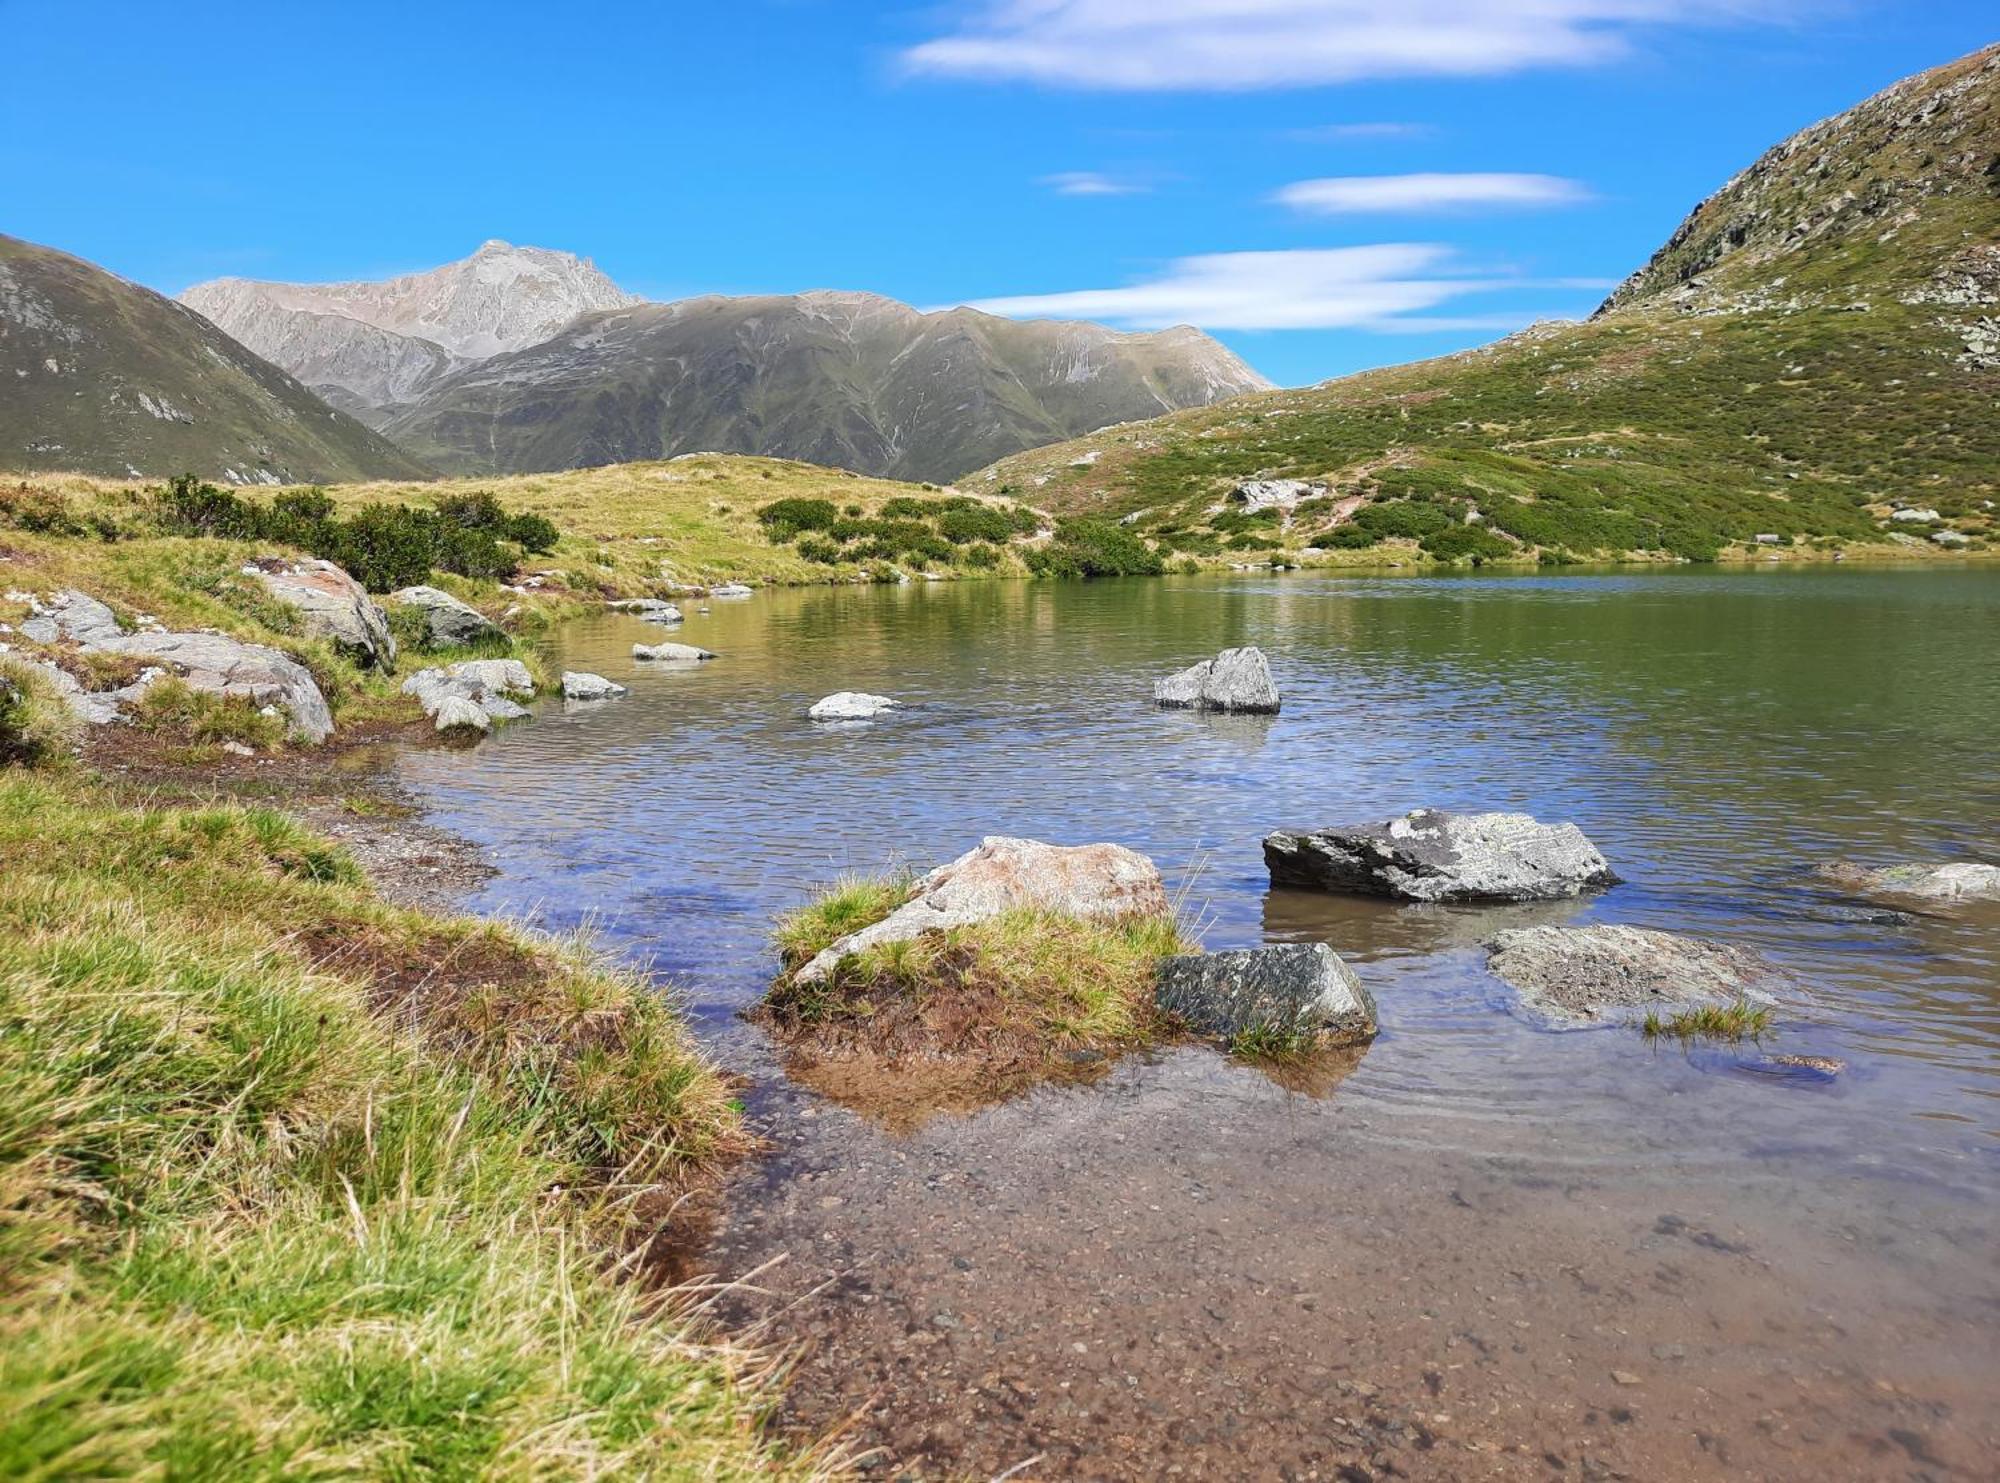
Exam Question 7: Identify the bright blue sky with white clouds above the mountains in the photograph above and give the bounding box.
[0,0,2000,384]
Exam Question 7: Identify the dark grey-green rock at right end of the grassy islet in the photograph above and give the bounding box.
[1154,941,1376,1045]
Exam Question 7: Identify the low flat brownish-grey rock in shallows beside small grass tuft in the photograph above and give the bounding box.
[1486,927,1790,1029]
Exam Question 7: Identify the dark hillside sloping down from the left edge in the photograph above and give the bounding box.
[0,236,426,484]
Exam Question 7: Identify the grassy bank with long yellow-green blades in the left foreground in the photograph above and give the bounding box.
[0,767,792,1479]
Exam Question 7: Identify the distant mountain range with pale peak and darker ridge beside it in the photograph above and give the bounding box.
[182,242,1268,480]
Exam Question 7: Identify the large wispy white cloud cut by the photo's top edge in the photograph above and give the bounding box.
[902,0,1802,92]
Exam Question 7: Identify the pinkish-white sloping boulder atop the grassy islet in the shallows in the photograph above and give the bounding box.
[792,835,1168,983]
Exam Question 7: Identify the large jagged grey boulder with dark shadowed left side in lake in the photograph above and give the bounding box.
[1264,809,1618,901]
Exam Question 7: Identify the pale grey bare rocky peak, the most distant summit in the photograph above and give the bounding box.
[180,240,638,422]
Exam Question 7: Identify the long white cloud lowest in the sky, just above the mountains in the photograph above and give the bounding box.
[944,242,1522,330]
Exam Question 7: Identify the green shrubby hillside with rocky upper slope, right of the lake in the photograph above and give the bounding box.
[962,48,2000,562]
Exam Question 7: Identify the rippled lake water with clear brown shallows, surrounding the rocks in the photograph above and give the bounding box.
[400,568,2000,1479]
